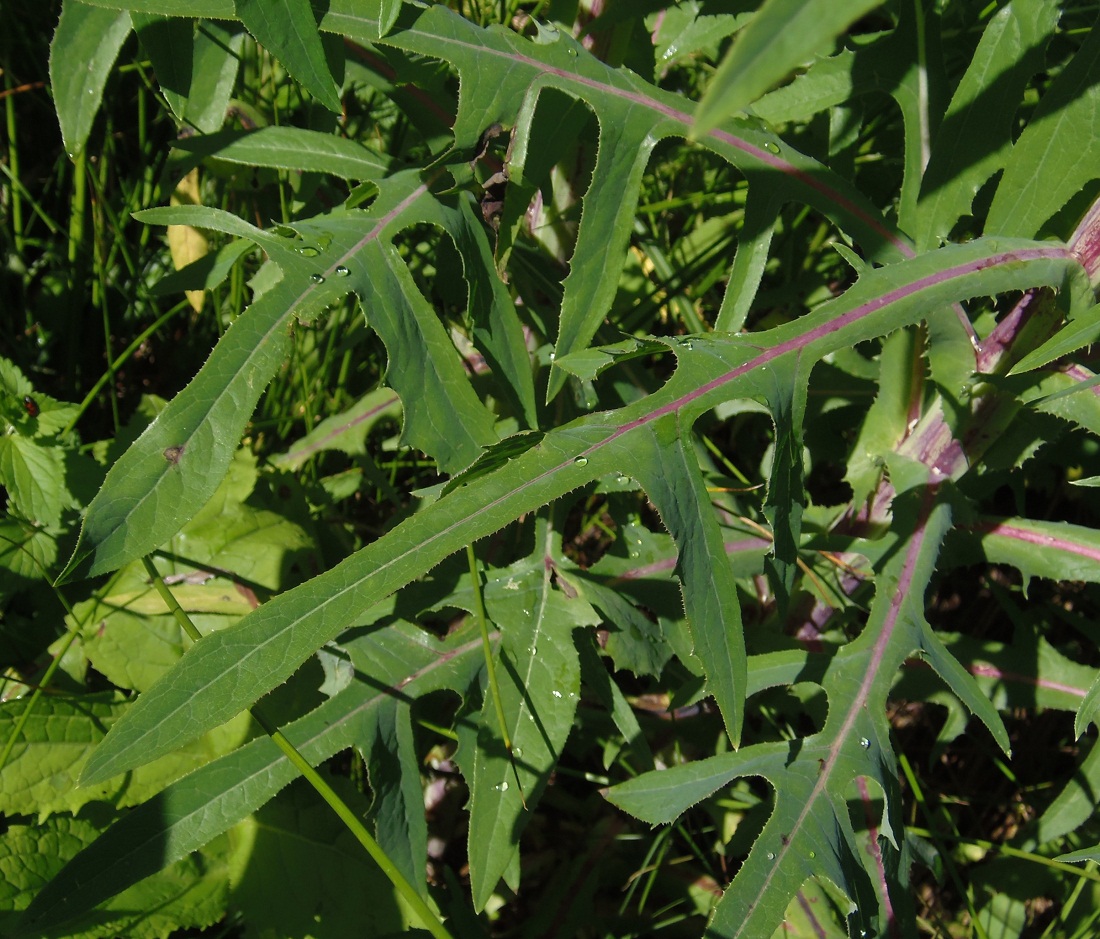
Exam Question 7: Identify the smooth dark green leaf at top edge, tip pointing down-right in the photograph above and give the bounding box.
[234,0,341,114]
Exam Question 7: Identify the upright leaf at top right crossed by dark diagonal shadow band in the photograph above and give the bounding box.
[914,0,1059,248]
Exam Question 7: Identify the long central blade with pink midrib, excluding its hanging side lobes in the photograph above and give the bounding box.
[77,235,1078,783]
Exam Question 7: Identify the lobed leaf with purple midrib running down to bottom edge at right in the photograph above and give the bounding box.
[608,477,950,937]
